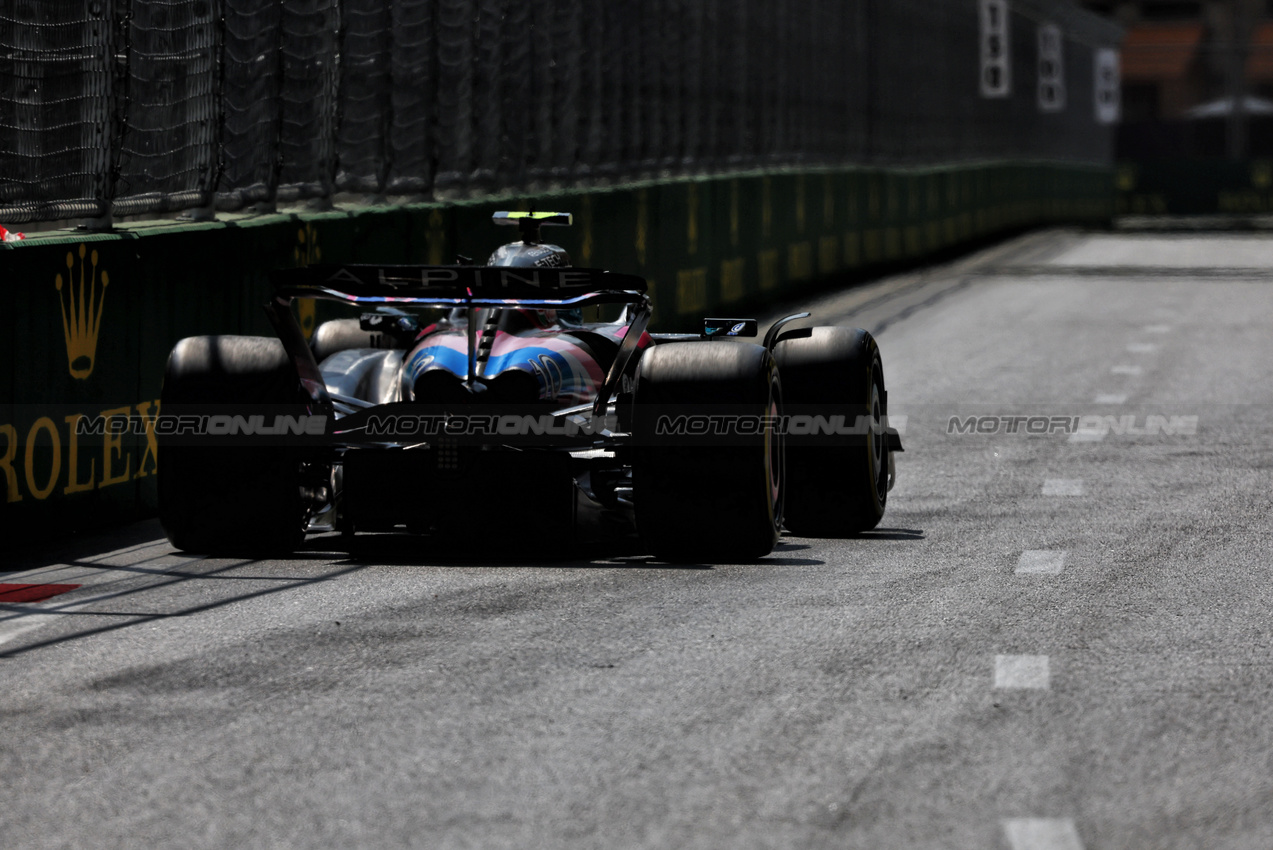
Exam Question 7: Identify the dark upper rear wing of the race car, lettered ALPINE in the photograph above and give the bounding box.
[271,266,648,309]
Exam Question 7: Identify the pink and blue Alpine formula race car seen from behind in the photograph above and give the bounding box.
[157,213,901,562]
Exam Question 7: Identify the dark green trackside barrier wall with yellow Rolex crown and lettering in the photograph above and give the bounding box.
[0,163,1114,541]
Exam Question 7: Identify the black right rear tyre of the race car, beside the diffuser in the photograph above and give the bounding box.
[633,342,784,562]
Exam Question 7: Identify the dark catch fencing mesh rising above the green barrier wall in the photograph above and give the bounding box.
[0,0,1119,223]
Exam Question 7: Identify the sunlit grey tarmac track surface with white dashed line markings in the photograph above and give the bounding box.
[0,230,1273,850]
